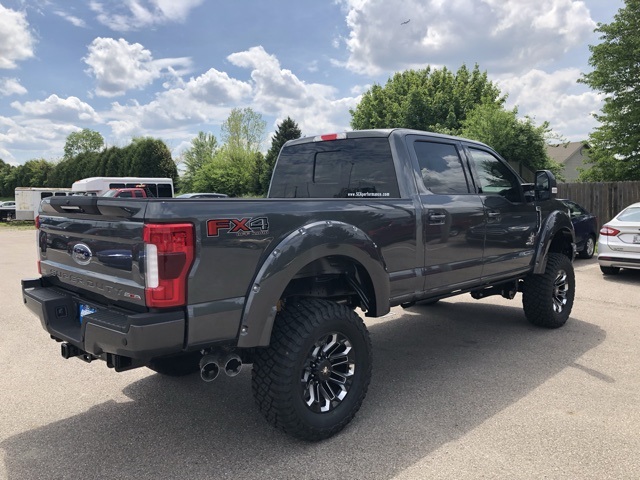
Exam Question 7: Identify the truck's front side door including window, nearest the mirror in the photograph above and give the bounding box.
[467,145,540,278]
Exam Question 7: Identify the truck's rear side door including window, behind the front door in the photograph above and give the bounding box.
[408,135,485,293]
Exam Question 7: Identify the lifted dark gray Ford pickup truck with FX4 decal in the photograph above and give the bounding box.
[22,129,575,440]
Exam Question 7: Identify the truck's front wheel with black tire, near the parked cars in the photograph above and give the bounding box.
[522,253,576,328]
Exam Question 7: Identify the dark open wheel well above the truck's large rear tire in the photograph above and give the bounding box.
[282,255,376,311]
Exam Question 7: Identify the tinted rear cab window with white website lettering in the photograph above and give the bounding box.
[269,138,400,198]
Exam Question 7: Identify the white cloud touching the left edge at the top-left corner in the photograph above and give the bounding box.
[0,4,35,68]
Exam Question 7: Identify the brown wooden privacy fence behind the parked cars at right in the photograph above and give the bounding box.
[558,182,640,228]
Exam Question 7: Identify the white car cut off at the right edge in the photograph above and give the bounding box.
[598,203,640,275]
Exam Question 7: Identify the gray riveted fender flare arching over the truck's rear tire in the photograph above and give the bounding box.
[238,221,391,348]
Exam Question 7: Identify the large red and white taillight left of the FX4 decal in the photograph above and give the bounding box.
[143,223,194,307]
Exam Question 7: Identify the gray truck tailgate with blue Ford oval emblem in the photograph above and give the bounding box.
[38,196,146,308]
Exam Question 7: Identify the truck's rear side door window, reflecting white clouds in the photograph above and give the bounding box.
[413,141,469,194]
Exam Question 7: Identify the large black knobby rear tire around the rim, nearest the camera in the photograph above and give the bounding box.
[251,299,372,441]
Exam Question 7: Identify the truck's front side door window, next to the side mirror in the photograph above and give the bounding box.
[470,148,522,202]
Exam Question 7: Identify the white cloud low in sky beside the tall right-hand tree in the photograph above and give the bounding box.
[497,68,602,141]
